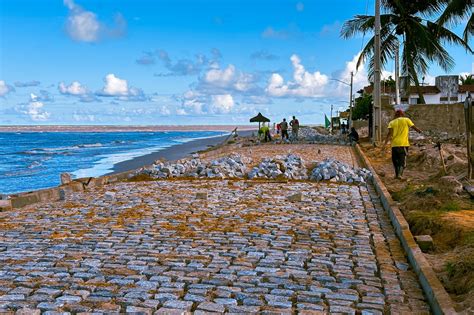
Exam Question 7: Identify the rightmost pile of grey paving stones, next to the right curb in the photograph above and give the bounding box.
[310,159,372,183]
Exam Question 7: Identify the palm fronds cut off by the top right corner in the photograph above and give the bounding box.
[437,0,474,42]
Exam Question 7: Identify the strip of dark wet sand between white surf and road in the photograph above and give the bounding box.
[109,130,255,176]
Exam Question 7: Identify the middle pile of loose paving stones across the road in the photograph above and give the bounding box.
[247,154,308,179]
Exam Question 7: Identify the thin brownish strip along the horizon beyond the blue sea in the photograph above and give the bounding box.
[0,125,257,132]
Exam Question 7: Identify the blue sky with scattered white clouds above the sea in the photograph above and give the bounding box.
[0,0,474,125]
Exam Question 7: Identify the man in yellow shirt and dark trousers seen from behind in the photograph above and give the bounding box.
[383,109,422,179]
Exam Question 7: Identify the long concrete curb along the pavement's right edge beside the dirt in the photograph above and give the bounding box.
[355,144,457,314]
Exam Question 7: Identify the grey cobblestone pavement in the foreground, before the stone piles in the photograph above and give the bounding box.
[0,180,429,314]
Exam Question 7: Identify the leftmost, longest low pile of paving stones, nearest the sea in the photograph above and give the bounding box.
[139,154,249,179]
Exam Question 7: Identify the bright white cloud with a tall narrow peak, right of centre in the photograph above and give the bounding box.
[266,54,329,97]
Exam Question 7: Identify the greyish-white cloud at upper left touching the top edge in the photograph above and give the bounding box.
[64,0,126,42]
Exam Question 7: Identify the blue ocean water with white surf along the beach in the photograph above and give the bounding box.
[0,131,223,194]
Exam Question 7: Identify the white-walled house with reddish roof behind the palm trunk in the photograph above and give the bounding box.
[363,75,474,105]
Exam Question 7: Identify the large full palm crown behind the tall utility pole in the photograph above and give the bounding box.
[341,0,472,103]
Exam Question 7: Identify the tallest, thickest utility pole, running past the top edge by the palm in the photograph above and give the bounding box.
[372,0,382,145]
